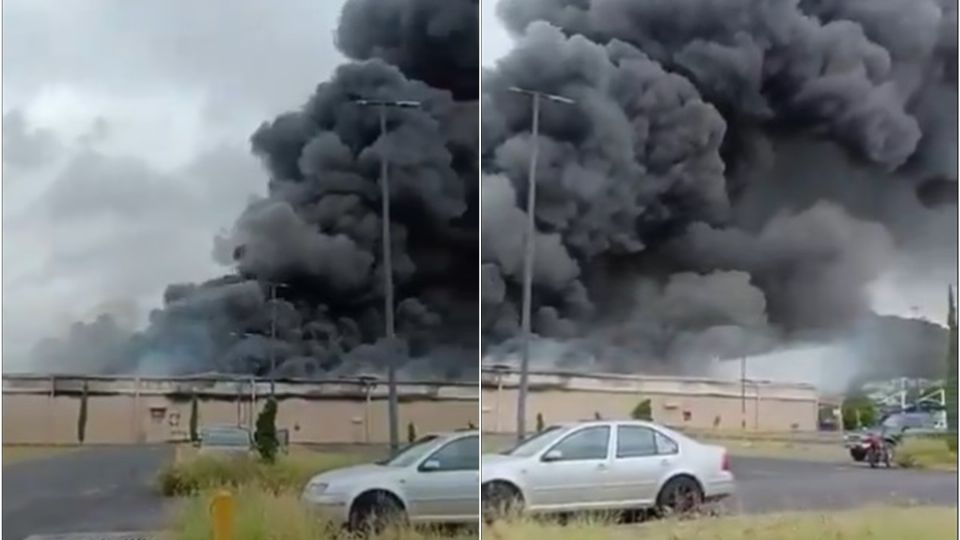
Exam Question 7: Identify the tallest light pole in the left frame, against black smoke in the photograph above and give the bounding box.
[353,99,421,452]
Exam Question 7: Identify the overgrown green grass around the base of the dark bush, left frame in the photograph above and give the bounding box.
[157,447,370,497]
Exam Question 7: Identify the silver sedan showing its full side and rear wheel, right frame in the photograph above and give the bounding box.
[481,421,736,519]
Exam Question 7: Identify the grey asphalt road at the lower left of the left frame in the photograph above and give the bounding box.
[3,446,173,540]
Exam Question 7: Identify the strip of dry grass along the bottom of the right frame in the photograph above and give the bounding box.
[492,507,957,540]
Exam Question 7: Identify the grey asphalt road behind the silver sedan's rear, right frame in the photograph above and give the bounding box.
[727,457,957,513]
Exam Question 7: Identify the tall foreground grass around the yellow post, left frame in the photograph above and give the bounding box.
[169,488,479,540]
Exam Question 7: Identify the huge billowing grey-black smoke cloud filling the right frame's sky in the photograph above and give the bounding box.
[481,0,957,384]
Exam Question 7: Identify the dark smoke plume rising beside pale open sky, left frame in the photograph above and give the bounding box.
[36,0,479,379]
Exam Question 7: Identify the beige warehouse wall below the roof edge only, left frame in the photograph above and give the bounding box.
[3,393,479,444]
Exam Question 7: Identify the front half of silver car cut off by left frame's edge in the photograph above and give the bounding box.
[302,431,480,529]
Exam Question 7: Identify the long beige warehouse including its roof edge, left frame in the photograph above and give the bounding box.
[3,377,479,444]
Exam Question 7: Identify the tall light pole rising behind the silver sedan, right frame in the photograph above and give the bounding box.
[509,86,575,441]
